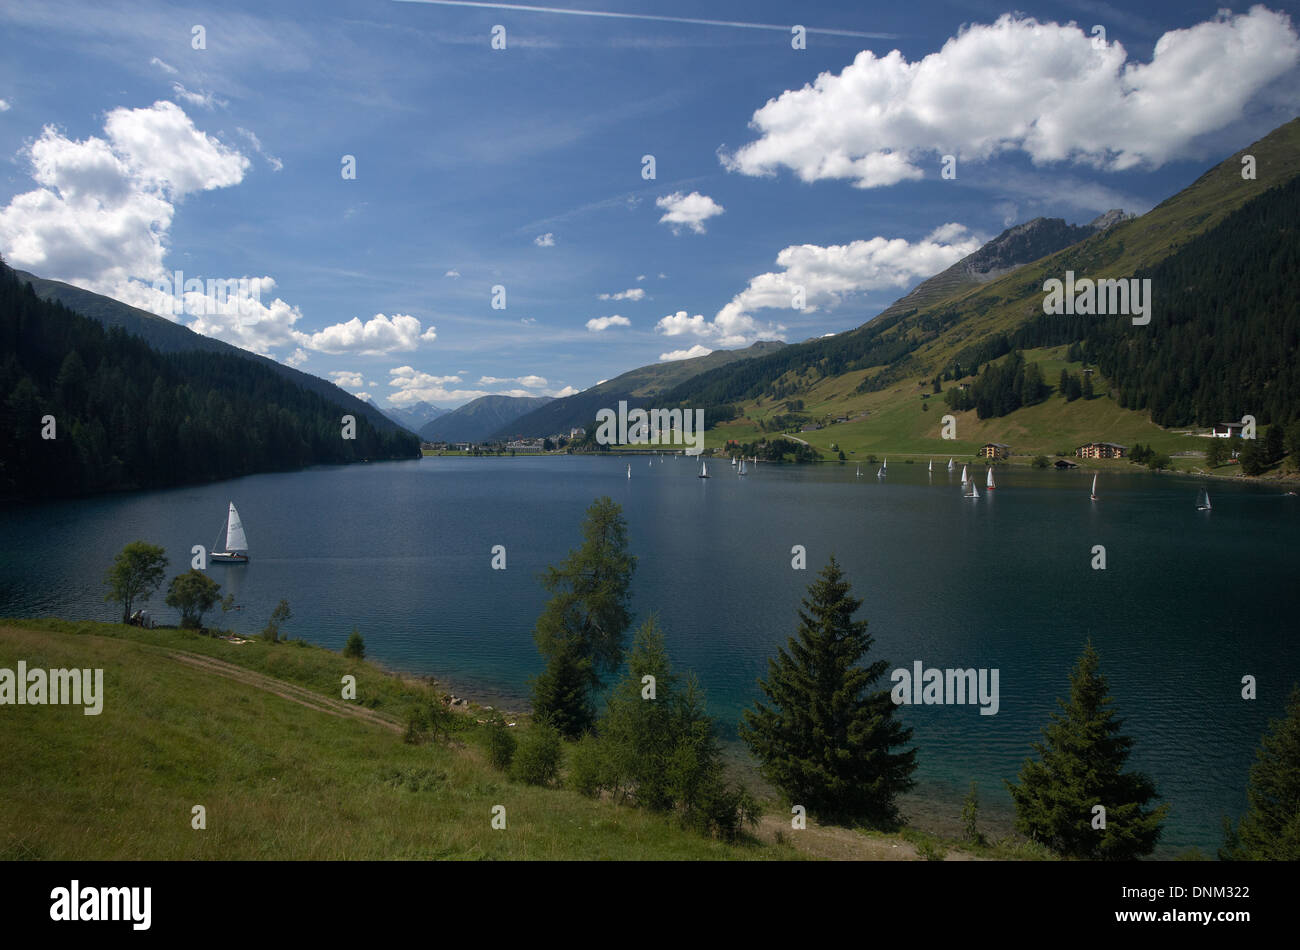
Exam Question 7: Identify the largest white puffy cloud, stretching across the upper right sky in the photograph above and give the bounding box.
[719,5,1300,188]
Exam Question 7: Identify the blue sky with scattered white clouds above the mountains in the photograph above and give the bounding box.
[0,0,1300,407]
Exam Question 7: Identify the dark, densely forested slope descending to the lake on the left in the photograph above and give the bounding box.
[0,261,420,498]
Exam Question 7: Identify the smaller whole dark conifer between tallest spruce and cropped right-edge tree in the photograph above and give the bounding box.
[1008,641,1169,860]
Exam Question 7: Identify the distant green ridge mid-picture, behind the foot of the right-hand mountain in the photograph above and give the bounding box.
[494,340,785,438]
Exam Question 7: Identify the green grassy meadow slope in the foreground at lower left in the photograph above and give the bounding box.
[0,620,798,860]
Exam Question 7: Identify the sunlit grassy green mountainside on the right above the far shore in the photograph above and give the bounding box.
[681,120,1300,455]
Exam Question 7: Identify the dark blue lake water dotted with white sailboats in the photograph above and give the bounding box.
[0,457,1300,854]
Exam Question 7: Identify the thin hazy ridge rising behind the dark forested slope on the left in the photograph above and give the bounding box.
[14,270,406,431]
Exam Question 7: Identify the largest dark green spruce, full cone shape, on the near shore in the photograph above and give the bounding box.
[741,556,917,825]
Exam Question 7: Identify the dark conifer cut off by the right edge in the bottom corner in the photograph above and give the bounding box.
[1219,686,1300,860]
